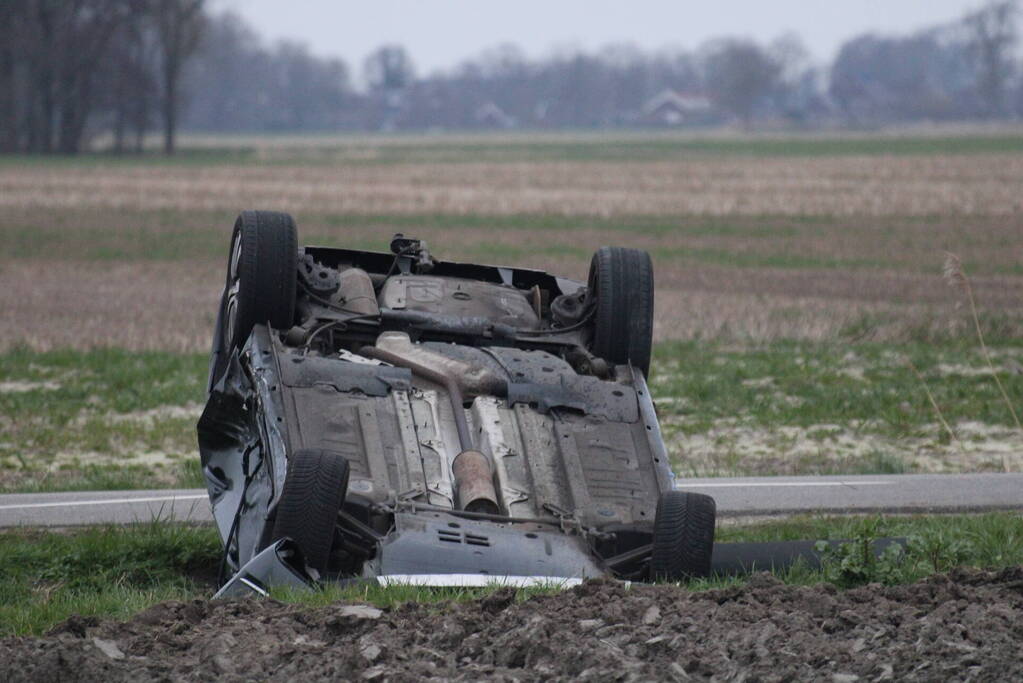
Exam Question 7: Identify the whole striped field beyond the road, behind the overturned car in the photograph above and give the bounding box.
[0,132,1023,491]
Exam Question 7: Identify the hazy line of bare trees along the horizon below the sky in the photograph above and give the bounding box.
[0,0,1023,153]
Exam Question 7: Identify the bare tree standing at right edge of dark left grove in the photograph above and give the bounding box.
[152,0,206,154]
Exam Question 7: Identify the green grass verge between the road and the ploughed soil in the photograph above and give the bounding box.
[0,513,1023,636]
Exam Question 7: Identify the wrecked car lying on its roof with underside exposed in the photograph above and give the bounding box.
[198,212,715,594]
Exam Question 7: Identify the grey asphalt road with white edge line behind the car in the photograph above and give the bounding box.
[0,473,1023,528]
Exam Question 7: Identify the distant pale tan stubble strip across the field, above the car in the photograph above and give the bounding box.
[0,154,1023,217]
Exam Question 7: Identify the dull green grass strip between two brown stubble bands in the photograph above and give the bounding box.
[6,208,1020,276]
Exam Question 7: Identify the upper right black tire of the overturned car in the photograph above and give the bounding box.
[589,246,654,376]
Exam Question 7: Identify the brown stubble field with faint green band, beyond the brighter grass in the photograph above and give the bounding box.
[0,144,1023,351]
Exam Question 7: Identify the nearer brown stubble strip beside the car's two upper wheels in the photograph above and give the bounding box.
[0,257,1023,351]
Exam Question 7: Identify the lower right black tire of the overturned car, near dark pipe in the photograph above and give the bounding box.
[650,491,717,581]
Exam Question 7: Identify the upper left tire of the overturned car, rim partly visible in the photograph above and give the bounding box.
[221,211,299,352]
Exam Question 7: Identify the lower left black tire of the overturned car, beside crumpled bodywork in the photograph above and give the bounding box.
[273,449,349,575]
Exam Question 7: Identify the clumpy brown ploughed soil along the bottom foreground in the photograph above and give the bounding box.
[0,567,1023,681]
